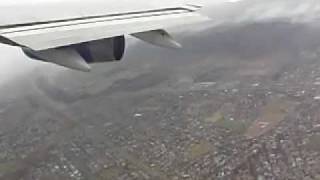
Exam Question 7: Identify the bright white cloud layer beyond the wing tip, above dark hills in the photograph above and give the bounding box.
[203,0,320,25]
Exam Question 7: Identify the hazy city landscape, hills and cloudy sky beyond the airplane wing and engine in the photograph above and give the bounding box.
[0,0,320,180]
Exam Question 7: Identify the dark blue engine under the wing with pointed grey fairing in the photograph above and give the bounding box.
[23,36,125,71]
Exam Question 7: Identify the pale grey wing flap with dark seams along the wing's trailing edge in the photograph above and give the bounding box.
[0,6,208,50]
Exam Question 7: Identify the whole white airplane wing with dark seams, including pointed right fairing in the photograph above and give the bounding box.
[0,0,208,71]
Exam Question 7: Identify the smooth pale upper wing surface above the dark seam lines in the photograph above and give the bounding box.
[0,0,183,27]
